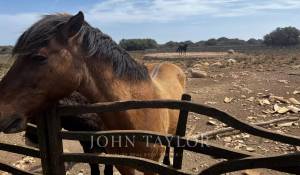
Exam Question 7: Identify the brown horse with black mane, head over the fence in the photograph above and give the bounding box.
[0,12,185,174]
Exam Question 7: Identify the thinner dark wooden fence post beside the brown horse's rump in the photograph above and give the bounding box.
[173,94,192,169]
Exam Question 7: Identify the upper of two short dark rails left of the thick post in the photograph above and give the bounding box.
[0,143,40,158]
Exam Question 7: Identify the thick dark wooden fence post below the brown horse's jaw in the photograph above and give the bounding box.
[38,106,66,175]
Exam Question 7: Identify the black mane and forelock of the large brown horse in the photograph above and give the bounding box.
[12,14,150,81]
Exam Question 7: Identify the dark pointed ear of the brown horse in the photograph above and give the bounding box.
[58,11,84,41]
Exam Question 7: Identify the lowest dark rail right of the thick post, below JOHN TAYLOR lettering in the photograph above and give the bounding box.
[63,153,190,175]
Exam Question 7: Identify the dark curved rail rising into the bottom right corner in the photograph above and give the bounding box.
[200,152,300,175]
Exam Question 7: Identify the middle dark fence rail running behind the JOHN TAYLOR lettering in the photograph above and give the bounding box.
[62,130,261,159]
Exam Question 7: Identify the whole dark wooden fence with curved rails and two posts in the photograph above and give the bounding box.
[0,95,300,175]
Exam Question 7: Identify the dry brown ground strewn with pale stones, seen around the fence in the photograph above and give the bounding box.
[0,50,300,175]
